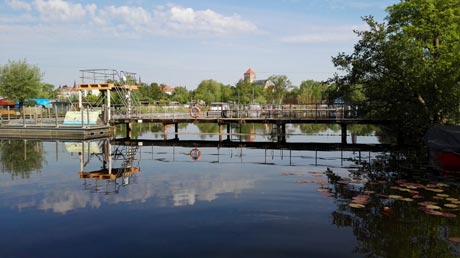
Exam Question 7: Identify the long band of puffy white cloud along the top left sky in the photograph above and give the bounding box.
[0,0,257,38]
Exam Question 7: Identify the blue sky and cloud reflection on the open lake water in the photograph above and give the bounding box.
[0,140,372,257]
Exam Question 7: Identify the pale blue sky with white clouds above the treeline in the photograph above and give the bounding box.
[0,0,399,90]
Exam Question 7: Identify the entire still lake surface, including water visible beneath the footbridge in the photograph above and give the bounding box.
[0,125,460,257]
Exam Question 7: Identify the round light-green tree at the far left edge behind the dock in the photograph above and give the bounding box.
[0,60,42,102]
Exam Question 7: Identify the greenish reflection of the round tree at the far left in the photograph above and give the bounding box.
[0,140,44,178]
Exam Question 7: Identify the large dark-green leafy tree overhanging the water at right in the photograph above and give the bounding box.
[332,0,460,143]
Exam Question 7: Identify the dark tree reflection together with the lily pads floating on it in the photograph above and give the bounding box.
[282,156,460,257]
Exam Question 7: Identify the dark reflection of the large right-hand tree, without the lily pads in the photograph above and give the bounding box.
[328,155,460,257]
